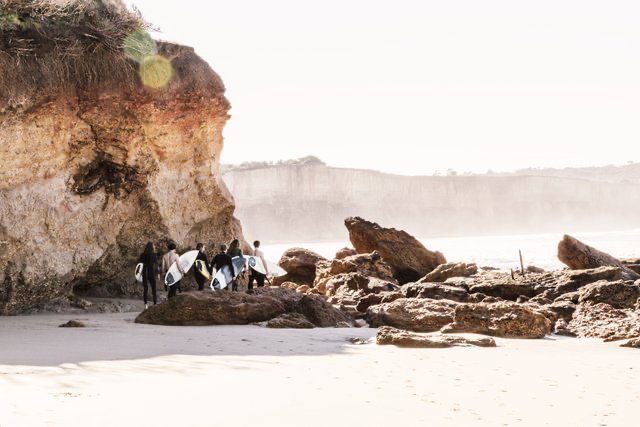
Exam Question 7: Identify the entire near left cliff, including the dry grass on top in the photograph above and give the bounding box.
[0,0,242,314]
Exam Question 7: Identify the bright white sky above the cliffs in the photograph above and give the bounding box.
[128,0,640,175]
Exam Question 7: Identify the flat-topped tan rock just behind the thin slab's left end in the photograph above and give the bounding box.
[366,298,458,332]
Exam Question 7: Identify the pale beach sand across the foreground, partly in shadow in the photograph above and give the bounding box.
[0,313,640,427]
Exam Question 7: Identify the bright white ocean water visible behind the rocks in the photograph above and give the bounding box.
[262,229,640,270]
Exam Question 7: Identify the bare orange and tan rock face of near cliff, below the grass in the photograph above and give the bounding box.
[0,2,242,314]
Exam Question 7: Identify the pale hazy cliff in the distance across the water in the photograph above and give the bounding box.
[224,165,640,242]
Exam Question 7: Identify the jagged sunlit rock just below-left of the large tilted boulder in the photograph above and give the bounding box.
[313,251,397,295]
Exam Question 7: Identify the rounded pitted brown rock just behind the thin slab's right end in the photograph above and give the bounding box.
[442,302,552,338]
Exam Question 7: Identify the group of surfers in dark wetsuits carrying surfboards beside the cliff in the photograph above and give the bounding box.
[138,239,269,308]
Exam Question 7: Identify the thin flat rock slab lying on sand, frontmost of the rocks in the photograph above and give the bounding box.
[376,326,496,348]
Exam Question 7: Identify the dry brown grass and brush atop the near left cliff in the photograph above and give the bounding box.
[0,0,148,110]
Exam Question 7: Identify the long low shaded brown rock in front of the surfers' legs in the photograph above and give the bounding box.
[135,288,351,327]
